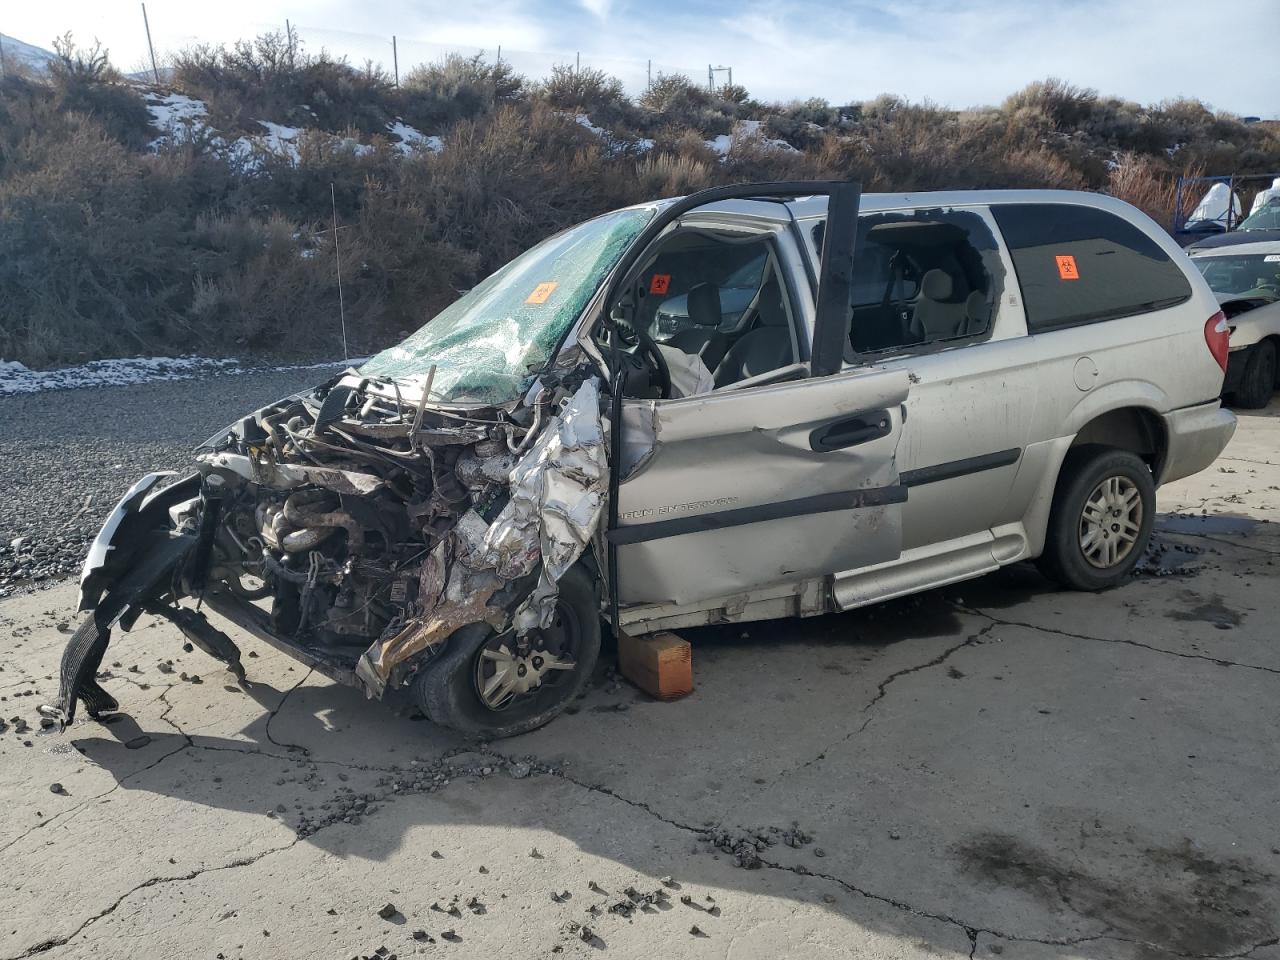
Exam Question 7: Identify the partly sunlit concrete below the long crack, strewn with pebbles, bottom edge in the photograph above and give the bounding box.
[35,776,970,959]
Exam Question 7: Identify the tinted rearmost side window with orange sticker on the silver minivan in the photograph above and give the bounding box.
[991,204,1192,333]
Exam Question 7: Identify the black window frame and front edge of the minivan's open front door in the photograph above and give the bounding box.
[593,180,863,631]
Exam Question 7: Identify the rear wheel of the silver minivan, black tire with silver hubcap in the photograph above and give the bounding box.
[1038,445,1156,590]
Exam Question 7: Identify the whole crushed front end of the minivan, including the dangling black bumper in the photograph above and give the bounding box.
[50,369,609,723]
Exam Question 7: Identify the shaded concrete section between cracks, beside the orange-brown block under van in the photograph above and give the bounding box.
[517,598,986,820]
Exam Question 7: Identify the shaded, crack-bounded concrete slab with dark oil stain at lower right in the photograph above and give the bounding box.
[721,626,1280,955]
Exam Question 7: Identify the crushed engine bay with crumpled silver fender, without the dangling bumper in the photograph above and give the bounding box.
[197,375,608,695]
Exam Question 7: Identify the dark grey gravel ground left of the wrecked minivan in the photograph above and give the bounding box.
[0,366,340,596]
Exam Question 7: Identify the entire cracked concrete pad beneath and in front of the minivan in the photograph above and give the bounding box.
[0,401,1280,960]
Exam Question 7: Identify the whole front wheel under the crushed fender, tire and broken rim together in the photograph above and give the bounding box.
[411,567,600,740]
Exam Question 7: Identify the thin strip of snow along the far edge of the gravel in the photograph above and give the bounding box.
[0,356,369,397]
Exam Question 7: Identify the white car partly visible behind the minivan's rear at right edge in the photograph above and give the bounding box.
[1192,241,1280,410]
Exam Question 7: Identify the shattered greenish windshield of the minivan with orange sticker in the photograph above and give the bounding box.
[360,209,654,403]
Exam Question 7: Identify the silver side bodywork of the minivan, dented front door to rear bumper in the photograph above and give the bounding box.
[618,191,1235,631]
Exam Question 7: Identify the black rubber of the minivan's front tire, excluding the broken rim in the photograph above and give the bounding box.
[411,566,600,740]
